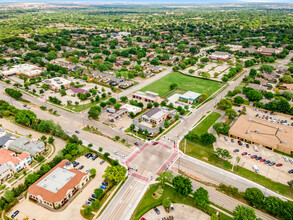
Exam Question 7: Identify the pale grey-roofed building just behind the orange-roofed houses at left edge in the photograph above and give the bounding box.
[5,137,46,157]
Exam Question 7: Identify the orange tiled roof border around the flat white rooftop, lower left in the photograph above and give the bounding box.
[28,160,87,203]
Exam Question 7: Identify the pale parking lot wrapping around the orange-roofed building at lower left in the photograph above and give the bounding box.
[7,156,109,220]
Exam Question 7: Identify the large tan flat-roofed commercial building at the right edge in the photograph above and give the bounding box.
[229,115,293,154]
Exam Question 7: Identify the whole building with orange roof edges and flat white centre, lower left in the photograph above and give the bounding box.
[27,160,89,209]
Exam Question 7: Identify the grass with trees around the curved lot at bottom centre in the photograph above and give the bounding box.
[131,184,231,220]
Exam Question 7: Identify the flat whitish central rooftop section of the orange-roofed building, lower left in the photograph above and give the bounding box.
[37,167,76,193]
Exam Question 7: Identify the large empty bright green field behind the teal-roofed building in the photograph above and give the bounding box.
[141,72,223,96]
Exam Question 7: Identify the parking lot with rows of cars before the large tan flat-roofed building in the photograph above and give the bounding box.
[214,136,293,185]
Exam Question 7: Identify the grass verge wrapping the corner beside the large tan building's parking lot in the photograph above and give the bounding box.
[180,112,293,198]
